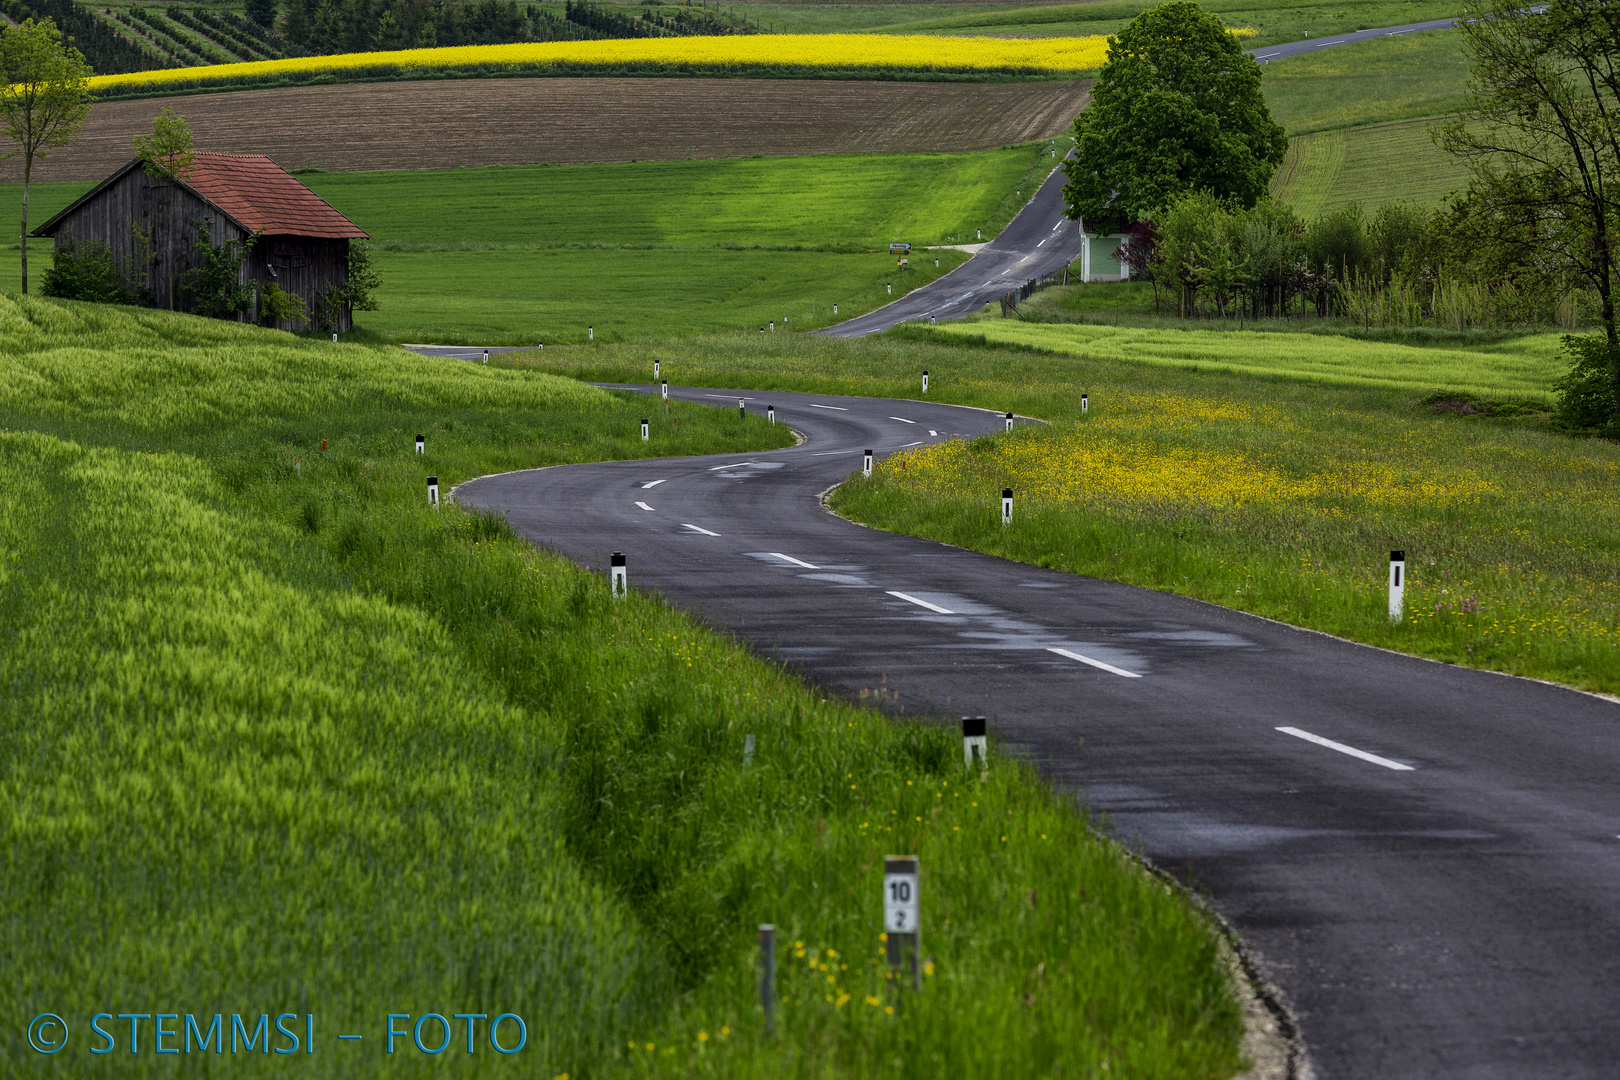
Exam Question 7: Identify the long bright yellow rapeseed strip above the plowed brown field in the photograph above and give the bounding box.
[91,34,1108,96]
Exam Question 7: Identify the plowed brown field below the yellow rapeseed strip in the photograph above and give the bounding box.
[9,78,1090,181]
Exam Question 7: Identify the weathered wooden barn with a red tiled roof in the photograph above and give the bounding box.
[32,151,366,330]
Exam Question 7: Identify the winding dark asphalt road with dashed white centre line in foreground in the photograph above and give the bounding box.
[454,387,1620,1080]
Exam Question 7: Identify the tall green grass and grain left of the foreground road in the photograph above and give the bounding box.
[0,298,1239,1077]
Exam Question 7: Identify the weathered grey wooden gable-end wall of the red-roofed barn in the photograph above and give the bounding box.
[57,168,245,311]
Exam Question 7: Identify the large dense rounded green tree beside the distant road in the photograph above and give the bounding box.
[1063,0,1288,220]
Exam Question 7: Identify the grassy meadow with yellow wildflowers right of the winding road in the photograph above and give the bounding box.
[512,324,1620,693]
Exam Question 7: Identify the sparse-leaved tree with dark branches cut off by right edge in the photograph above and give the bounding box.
[1437,0,1620,424]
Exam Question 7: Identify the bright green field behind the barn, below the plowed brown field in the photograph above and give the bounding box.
[0,146,1051,345]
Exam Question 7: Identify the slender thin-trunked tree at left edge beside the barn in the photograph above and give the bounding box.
[0,19,91,293]
